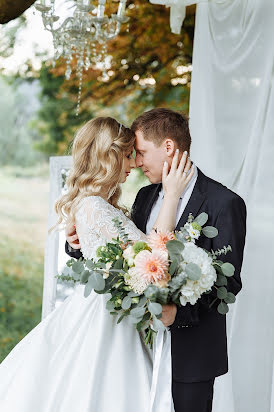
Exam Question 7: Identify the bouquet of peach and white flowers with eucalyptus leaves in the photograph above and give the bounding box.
[56,213,235,347]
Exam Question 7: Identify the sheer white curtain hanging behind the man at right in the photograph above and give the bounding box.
[190,0,274,412]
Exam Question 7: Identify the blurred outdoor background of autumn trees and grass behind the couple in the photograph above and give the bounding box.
[0,0,195,361]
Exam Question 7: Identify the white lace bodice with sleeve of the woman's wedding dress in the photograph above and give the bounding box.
[75,196,146,260]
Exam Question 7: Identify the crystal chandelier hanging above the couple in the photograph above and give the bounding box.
[35,0,129,115]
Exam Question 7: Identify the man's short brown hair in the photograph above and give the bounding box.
[131,107,191,153]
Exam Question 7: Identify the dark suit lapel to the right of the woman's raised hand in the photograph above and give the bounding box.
[176,168,207,230]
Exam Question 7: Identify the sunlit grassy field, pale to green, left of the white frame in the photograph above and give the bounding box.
[0,165,49,361]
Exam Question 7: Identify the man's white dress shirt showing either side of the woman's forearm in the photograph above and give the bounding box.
[146,163,198,234]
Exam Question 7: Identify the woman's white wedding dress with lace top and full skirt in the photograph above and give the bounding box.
[0,196,157,412]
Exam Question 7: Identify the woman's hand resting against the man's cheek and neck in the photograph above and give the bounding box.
[162,149,194,198]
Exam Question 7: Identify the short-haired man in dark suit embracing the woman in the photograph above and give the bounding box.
[66,108,246,412]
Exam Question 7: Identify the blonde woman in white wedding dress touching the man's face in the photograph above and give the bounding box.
[0,117,193,412]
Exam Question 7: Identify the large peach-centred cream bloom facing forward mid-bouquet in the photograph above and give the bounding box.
[134,249,168,283]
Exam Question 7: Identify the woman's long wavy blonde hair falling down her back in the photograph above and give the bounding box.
[50,117,135,231]
